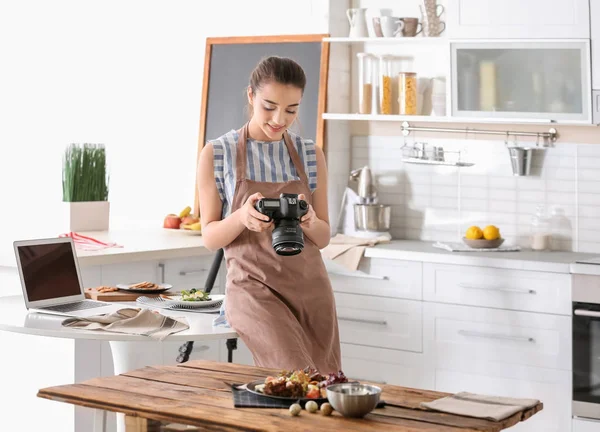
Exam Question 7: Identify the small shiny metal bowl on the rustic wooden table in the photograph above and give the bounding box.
[327,383,381,417]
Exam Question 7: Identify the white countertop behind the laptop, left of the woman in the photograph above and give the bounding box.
[0,228,211,267]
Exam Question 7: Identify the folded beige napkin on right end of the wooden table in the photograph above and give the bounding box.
[421,392,540,421]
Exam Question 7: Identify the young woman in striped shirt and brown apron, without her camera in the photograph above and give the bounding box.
[198,57,341,374]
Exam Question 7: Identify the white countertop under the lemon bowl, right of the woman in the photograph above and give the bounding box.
[365,240,598,273]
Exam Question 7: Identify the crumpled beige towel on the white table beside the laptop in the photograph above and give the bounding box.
[62,308,190,340]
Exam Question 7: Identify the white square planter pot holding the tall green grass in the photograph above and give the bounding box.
[63,201,110,231]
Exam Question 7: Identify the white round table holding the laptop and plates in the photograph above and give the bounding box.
[0,296,238,430]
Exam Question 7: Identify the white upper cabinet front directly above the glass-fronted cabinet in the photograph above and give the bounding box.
[447,0,597,39]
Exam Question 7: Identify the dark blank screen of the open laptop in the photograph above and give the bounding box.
[18,243,81,302]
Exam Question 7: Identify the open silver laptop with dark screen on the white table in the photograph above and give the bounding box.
[13,237,122,317]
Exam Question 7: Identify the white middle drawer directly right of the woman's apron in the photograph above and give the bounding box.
[335,293,423,352]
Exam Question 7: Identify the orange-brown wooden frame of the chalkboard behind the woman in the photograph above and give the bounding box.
[193,34,329,215]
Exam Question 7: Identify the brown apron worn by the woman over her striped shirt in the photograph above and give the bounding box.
[225,124,341,374]
